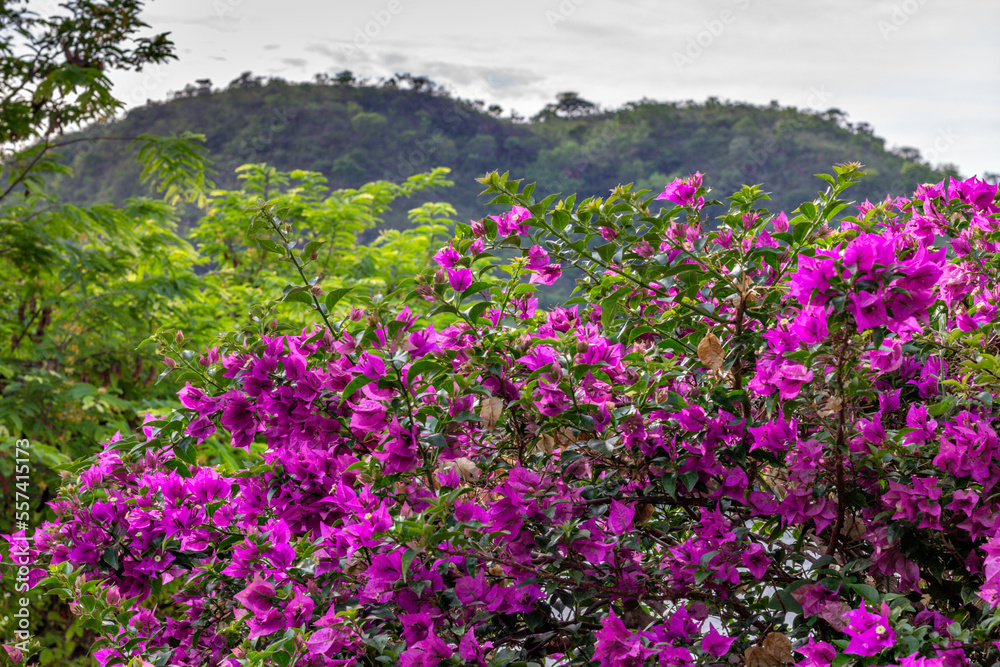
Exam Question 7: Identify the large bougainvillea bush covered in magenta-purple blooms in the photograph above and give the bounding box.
[12,165,1000,667]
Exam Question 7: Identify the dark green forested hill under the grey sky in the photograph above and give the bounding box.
[50,72,954,227]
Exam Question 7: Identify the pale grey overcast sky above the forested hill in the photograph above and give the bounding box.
[90,0,1000,176]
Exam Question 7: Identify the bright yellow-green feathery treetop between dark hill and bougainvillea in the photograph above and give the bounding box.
[190,164,454,343]
